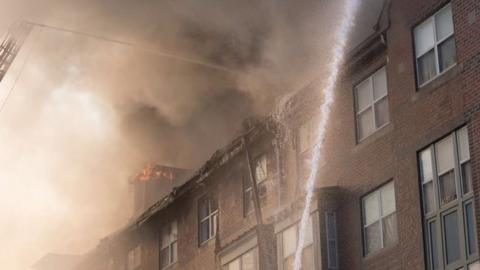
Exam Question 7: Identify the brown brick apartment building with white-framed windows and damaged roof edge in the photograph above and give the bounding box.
[72,0,480,270]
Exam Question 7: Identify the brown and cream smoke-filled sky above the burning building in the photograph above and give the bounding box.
[0,0,381,270]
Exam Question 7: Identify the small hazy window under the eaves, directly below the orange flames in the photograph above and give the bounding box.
[160,221,177,269]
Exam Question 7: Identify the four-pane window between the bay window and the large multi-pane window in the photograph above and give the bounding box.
[362,181,398,255]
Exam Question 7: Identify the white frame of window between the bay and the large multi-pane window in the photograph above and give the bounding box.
[360,179,399,257]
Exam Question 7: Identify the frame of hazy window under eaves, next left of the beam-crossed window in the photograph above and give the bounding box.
[197,195,219,246]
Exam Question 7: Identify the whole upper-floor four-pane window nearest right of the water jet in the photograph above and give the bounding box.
[354,67,390,141]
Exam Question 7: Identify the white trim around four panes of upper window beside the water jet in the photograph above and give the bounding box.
[353,65,390,142]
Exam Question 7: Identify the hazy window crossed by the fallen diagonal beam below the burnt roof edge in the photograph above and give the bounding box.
[243,154,268,215]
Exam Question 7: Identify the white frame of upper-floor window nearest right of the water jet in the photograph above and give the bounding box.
[353,66,391,143]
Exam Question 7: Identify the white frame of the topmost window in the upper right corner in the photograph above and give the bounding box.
[412,1,458,89]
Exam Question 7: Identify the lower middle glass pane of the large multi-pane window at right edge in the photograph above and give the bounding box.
[443,212,460,264]
